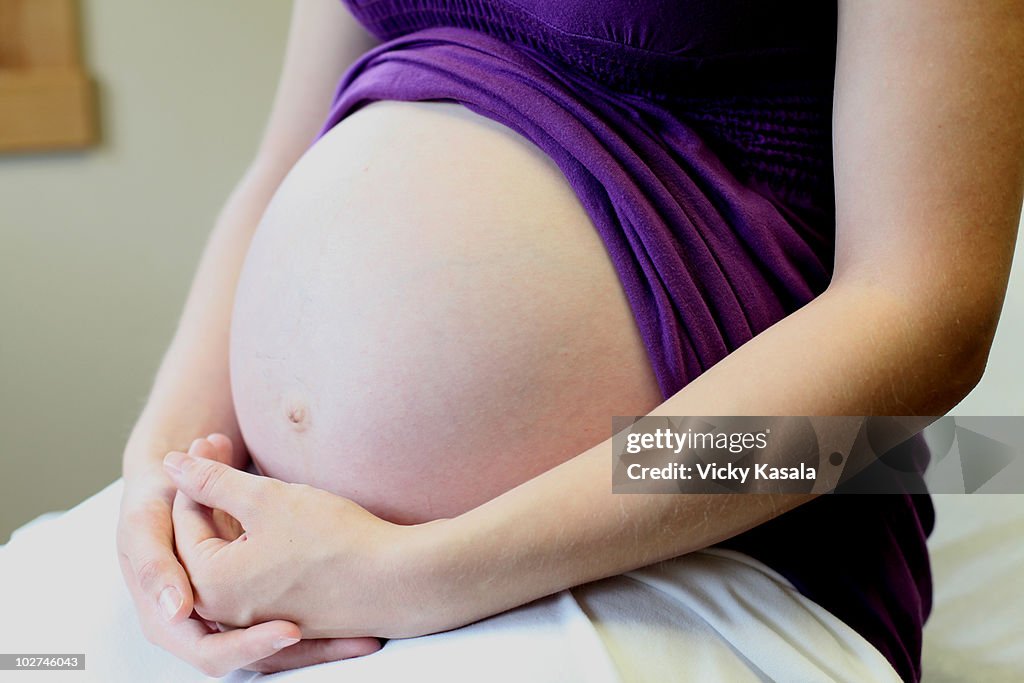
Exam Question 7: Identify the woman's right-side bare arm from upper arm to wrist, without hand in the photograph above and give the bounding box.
[394,0,1024,635]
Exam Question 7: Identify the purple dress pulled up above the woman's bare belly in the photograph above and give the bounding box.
[321,0,934,680]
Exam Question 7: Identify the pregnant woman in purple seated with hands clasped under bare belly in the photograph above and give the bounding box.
[99,0,1024,680]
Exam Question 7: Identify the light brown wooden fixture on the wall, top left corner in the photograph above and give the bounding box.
[0,0,97,152]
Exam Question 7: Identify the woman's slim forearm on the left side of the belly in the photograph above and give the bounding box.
[124,161,287,481]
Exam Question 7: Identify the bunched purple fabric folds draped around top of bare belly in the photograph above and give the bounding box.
[323,28,830,397]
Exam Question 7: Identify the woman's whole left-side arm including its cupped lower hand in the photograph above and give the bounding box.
[118,0,380,673]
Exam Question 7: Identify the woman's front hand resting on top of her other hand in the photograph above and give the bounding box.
[164,436,417,647]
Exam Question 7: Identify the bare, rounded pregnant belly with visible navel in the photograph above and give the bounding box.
[230,102,660,523]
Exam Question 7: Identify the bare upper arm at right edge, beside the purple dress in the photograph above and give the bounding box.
[834,0,1024,335]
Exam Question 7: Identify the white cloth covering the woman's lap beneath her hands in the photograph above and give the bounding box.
[0,481,899,683]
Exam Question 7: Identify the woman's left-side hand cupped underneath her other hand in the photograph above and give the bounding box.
[117,436,301,676]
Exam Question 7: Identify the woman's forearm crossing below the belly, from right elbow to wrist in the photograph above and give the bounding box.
[401,287,984,632]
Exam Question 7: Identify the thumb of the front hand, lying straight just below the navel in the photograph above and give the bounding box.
[164,451,275,528]
